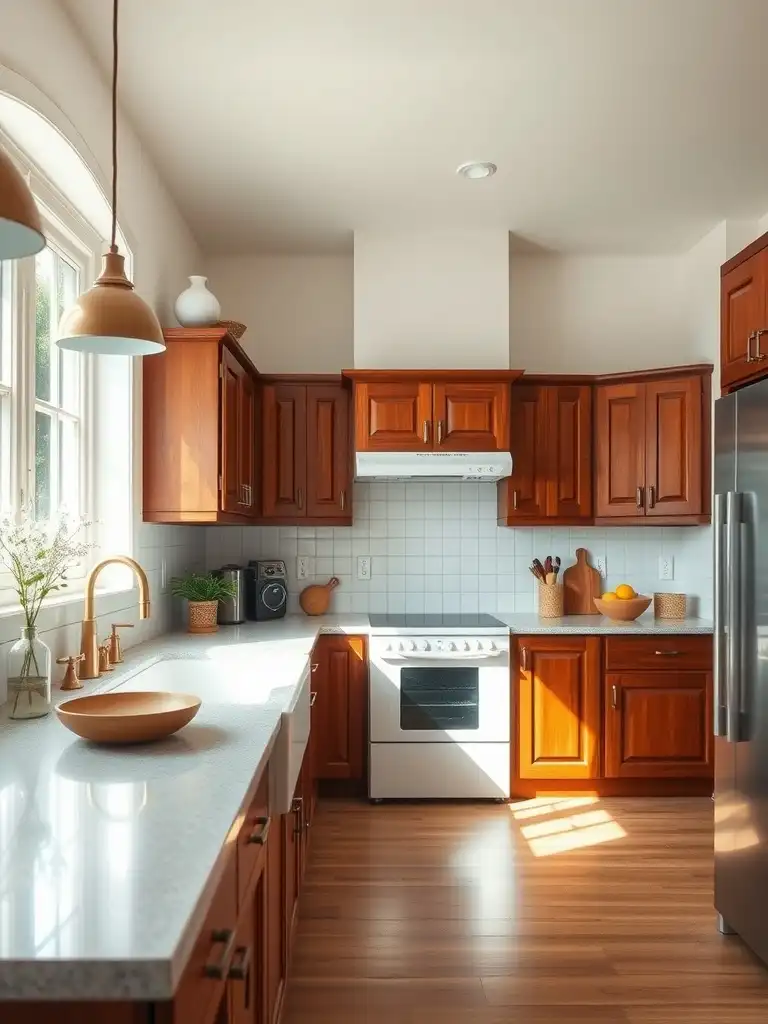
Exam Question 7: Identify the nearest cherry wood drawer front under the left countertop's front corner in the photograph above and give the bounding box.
[172,856,238,1024]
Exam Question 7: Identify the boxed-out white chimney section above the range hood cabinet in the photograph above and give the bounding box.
[354,229,509,370]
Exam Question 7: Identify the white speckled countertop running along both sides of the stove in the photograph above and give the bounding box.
[0,613,712,1000]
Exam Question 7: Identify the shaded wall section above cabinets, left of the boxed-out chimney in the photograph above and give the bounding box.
[208,255,353,374]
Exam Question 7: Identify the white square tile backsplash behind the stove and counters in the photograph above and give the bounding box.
[204,481,712,615]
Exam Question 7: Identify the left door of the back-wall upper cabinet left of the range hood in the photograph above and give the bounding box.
[262,384,306,518]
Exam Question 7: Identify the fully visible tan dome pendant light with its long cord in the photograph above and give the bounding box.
[56,0,165,355]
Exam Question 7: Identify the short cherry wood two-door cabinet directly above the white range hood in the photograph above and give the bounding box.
[344,370,520,452]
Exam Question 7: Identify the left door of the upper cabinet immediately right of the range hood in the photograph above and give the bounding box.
[499,384,548,522]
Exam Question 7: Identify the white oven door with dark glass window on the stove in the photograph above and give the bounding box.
[370,653,510,743]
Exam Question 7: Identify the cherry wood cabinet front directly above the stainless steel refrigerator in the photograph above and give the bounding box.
[720,251,768,387]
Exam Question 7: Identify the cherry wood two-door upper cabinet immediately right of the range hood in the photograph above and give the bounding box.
[499,382,592,525]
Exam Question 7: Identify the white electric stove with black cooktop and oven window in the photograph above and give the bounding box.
[369,614,511,800]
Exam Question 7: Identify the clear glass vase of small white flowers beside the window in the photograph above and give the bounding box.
[0,508,93,719]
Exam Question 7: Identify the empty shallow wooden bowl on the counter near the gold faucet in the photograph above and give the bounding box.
[56,690,201,743]
